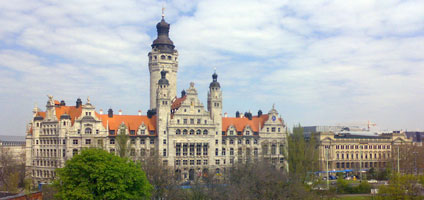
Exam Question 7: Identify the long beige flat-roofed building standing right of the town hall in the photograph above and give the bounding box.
[315,132,411,171]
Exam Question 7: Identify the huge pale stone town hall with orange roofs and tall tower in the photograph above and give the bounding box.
[26,17,287,183]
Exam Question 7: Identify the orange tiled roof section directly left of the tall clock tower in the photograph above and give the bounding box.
[96,113,156,131]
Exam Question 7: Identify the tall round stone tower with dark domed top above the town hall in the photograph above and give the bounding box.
[148,10,178,109]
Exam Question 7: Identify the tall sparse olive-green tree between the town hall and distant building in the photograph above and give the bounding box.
[288,125,318,181]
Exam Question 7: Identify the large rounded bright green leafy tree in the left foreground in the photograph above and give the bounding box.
[54,148,152,200]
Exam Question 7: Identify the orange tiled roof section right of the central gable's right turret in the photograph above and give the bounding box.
[222,115,268,132]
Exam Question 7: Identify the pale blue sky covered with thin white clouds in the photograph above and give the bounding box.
[0,0,424,135]
